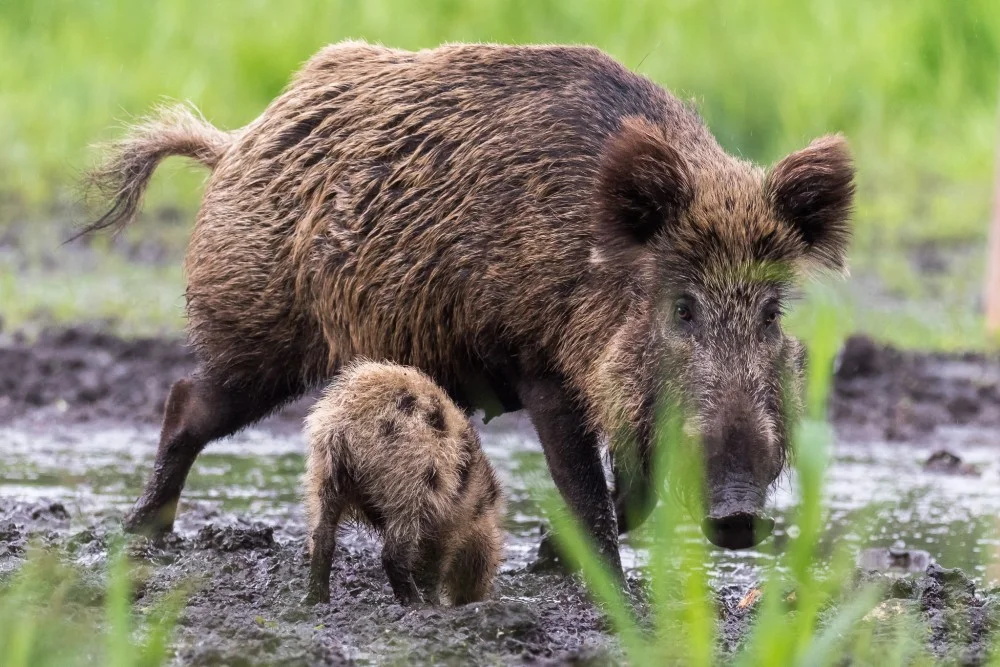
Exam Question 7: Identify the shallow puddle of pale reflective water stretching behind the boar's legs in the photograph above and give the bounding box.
[0,415,1000,585]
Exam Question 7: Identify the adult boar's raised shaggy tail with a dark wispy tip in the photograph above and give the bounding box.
[69,104,237,241]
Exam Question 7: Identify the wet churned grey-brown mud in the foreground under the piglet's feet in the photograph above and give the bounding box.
[0,497,620,665]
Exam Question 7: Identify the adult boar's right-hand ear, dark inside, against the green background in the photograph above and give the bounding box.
[766,135,854,271]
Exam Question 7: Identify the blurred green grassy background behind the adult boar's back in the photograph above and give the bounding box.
[0,0,1000,348]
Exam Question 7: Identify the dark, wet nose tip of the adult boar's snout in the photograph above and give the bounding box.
[701,483,774,549]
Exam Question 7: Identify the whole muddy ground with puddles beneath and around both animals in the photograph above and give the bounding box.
[0,327,1000,665]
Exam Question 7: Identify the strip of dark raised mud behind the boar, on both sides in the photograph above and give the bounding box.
[7,326,1000,441]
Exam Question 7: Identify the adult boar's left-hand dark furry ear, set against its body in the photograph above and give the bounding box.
[597,117,694,245]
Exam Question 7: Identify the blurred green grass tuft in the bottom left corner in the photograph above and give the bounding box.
[0,549,185,667]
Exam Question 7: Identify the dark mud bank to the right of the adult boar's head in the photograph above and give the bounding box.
[830,336,1000,441]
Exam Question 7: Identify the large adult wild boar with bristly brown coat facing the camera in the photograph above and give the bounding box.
[86,42,853,568]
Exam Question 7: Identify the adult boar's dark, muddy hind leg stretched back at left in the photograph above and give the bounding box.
[124,373,301,535]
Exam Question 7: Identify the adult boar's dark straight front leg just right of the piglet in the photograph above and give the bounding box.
[518,377,624,580]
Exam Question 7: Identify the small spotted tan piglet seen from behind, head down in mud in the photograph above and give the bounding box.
[294,362,503,605]
